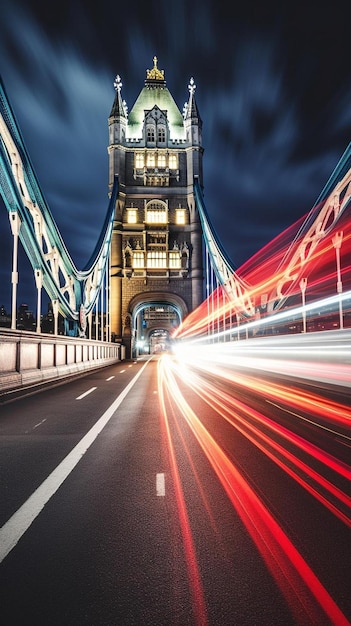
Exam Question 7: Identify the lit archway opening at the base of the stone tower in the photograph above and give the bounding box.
[125,292,188,358]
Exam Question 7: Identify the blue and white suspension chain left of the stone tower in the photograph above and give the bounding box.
[0,78,118,334]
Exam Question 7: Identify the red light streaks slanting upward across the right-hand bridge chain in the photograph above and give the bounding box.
[175,206,351,338]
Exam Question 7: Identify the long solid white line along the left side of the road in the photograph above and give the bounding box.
[0,362,147,563]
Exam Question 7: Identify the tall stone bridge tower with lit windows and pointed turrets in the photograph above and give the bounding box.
[108,57,204,356]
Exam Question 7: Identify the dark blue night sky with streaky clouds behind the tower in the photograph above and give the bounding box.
[0,0,351,310]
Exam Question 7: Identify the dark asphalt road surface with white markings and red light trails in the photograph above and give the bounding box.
[0,357,351,626]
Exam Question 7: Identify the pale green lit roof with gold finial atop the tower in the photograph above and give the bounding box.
[128,57,185,139]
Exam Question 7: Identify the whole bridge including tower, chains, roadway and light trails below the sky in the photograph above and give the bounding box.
[0,58,351,626]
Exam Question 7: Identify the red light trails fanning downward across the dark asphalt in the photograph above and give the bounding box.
[159,355,351,626]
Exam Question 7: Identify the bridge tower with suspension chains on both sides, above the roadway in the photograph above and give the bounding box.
[0,57,351,376]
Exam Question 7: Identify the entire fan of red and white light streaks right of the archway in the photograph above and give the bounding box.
[168,174,351,626]
